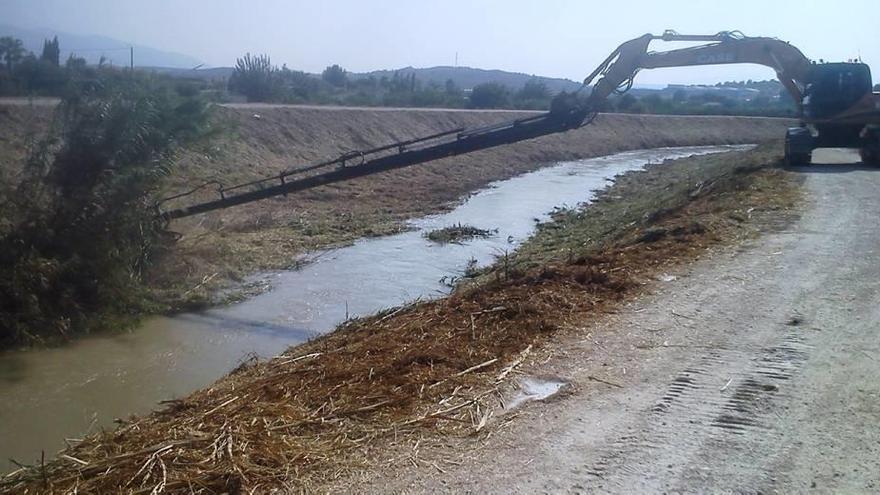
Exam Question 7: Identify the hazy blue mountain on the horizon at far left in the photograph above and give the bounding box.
[0,25,201,69]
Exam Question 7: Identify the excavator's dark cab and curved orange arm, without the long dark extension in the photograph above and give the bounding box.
[560,31,880,165]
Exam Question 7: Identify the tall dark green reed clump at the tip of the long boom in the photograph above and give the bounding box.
[0,71,207,345]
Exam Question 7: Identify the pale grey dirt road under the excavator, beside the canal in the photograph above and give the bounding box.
[364,150,880,493]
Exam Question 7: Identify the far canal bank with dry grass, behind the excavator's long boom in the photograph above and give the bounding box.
[0,101,788,346]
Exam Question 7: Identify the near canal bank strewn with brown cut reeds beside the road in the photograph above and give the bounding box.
[0,143,799,493]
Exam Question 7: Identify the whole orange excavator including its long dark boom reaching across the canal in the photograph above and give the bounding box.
[156,30,880,221]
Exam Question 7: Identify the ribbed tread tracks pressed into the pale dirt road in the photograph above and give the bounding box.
[572,330,811,492]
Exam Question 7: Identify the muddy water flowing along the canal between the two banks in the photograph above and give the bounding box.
[0,146,737,471]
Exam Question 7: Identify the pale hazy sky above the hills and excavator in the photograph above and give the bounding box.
[0,0,880,84]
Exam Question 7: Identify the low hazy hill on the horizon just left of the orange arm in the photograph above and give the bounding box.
[349,66,580,93]
